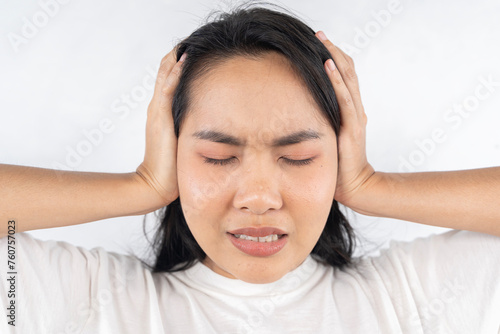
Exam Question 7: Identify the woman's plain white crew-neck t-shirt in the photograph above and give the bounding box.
[0,230,500,334]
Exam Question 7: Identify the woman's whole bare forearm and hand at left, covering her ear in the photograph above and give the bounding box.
[0,49,186,238]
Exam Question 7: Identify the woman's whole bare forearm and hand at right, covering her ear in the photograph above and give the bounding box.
[316,32,500,236]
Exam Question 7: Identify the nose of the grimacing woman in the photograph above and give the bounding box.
[233,166,283,215]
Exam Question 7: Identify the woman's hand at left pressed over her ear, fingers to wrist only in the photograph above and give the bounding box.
[136,48,185,206]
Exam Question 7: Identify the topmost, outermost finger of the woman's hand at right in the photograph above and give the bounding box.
[316,32,364,121]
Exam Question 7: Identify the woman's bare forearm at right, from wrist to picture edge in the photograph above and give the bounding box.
[346,167,500,236]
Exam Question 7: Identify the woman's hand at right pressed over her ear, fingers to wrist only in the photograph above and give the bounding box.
[316,31,375,209]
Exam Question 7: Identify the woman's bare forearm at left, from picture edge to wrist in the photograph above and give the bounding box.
[0,164,169,236]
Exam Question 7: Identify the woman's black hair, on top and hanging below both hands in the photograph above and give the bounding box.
[141,3,355,272]
